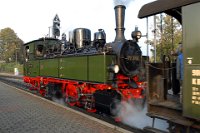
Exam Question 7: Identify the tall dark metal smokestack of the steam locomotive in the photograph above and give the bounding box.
[114,5,126,42]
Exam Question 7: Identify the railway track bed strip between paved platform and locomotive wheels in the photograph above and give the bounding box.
[0,74,146,133]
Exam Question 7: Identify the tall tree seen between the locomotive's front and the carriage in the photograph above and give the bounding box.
[151,15,182,62]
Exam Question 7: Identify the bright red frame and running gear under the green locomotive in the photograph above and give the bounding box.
[23,74,146,112]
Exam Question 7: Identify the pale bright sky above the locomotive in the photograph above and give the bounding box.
[0,0,153,54]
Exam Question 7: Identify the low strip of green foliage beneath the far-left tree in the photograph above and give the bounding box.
[0,62,23,75]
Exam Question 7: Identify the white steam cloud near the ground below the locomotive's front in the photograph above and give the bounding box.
[117,101,169,131]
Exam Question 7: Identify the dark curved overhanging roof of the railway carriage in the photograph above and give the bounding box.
[138,0,200,22]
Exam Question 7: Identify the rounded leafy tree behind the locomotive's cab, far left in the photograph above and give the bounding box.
[0,28,23,63]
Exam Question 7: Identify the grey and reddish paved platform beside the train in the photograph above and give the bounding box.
[0,82,122,133]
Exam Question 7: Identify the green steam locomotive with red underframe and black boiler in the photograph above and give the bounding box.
[24,5,146,115]
